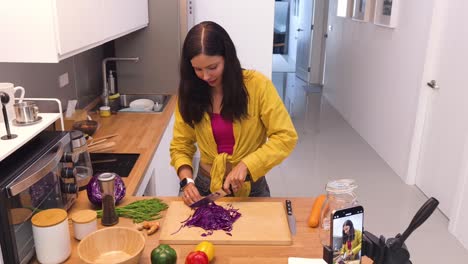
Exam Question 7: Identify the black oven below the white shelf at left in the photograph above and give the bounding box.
[0,131,78,264]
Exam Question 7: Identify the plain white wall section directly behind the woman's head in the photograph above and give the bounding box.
[188,0,275,78]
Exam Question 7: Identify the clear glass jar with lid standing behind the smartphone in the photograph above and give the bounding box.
[319,179,358,246]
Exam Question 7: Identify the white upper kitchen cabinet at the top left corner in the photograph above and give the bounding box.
[0,0,149,62]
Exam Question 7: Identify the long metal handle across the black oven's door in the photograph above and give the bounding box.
[8,142,64,197]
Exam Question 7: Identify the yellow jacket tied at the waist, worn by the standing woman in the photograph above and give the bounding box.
[170,70,297,196]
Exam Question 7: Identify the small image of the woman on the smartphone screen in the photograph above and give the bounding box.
[337,220,362,263]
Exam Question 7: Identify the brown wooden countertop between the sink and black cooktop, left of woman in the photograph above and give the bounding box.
[87,95,177,195]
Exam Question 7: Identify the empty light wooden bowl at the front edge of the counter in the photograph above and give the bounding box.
[78,227,145,264]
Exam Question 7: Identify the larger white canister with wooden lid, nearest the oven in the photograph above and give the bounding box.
[31,208,71,263]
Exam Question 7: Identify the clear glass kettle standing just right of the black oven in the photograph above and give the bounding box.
[70,130,93,191]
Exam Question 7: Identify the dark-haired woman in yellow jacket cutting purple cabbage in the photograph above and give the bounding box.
[170,22,297,205]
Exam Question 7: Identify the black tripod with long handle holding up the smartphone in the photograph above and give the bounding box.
[323,197,439,264]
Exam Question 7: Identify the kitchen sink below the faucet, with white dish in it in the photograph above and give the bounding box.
[120,94,171,113]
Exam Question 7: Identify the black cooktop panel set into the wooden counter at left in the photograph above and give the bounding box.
[89,153,140,177]
